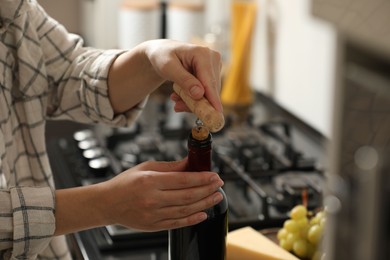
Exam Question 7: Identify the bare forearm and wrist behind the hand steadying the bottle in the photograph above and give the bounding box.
[54,184,109,235]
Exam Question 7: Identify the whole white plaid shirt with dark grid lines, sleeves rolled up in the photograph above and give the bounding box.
[0,0,143,259]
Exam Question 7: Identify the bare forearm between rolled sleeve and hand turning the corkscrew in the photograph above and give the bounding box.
[108,44,164,113]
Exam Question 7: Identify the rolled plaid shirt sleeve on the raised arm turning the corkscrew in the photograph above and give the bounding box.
[34,1,146,126]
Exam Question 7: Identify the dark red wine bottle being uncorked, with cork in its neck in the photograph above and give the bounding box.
[168,126,228,260]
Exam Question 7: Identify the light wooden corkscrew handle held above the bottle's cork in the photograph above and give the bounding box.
[173,83,225,133]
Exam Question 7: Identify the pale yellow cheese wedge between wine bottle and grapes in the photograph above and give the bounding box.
[226,227,299,260]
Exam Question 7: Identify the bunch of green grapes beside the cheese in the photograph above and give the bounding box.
[277,205,326,260]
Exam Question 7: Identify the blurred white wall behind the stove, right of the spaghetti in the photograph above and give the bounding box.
[251,0,336,137]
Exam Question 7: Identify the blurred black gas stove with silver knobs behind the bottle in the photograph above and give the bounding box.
[50,91,324,259]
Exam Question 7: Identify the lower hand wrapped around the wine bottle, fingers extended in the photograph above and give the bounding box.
[102,160,223,231]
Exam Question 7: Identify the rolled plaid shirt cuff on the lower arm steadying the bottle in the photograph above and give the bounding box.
[0,187,55,259]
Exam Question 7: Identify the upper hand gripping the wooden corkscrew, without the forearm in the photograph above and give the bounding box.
[145,40,222,112]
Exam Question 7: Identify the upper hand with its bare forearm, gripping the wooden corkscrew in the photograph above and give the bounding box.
[108,40,222,113]
